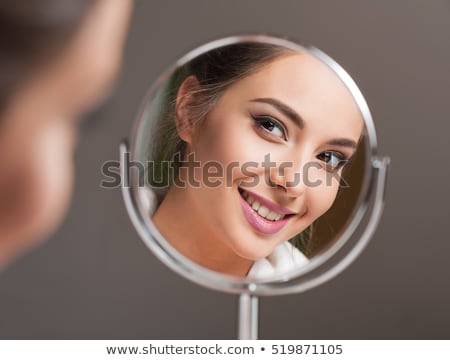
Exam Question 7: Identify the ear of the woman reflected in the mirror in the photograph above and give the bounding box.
[175,75,200,144]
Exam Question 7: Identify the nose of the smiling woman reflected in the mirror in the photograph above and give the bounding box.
[269,162,306,197]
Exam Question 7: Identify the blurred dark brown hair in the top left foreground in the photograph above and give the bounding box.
[0,0,98,115]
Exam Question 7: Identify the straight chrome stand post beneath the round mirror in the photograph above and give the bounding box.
[238,293,259,340]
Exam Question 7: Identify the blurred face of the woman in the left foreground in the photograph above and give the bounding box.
[0,0,132,267]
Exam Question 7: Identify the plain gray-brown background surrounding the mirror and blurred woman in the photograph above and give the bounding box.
[0,0,450,339]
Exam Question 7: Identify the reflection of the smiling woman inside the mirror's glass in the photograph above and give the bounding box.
[134,42,366,279]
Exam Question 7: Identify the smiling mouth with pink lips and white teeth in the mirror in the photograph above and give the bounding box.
[239,188,295,235]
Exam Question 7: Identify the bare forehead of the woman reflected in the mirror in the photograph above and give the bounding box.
[224,53,363,136]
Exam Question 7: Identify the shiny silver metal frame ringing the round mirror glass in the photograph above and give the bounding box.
[120,35,390,296]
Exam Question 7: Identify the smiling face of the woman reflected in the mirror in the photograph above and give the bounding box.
[179,53,363,260]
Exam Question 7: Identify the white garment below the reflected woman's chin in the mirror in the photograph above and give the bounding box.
[247,241,309,279]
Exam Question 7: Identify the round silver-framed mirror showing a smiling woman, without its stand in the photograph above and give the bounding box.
[121,36,387,295]
